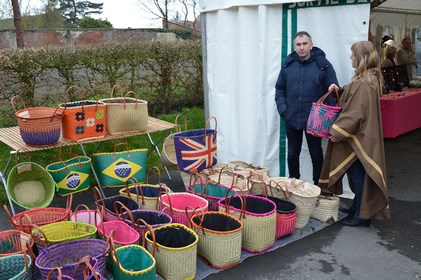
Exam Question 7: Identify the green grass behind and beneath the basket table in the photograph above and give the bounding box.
[0,108,206,205]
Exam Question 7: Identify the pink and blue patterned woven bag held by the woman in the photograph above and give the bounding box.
[307,88,342,138]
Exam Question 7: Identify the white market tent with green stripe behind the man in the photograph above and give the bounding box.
[200,0,421,185]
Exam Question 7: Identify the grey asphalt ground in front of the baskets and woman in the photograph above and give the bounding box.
[0,129,421,280]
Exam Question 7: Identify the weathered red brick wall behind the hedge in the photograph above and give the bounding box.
[0,29,175,49]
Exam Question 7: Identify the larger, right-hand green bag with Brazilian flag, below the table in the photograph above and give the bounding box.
[93,141,148,187]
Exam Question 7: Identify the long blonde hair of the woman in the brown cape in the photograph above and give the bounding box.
[351,41,383,95]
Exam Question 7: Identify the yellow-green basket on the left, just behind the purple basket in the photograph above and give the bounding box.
[32,221,97,250]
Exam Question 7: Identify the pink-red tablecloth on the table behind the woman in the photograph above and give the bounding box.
[380,89,421,138]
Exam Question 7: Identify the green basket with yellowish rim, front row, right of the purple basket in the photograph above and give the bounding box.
[110,234,156,280]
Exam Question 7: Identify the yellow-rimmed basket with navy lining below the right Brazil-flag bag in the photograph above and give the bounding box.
[119,166,170,210]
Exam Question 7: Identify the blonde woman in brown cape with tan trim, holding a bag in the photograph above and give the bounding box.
[319,41,390,226]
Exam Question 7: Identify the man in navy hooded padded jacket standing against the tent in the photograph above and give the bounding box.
[275,31,338,185]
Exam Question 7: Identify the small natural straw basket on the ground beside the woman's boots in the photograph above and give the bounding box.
[311,195,340,224]
